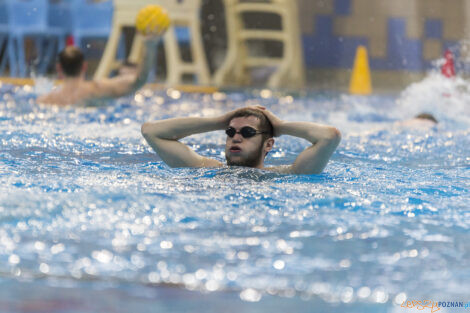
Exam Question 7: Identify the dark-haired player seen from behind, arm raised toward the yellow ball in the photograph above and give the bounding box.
[38,36,159,106]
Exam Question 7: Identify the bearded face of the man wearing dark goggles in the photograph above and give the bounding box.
[225,116,274,168]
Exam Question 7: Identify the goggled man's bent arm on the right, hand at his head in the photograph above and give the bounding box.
[258,107,341,174]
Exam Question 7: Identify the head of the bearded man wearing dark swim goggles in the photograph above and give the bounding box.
[225,108,274,167]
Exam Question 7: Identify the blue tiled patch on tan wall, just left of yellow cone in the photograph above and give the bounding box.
[303,16,367,68]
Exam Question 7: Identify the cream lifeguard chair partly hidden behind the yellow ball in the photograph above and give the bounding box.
[94,0,210,85]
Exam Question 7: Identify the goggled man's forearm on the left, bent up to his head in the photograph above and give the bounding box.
[142,117,226,140]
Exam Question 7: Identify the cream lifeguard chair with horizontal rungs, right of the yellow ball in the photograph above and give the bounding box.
[214,0,305,88]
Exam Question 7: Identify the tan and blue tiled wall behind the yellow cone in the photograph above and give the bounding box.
[298,0,464,73]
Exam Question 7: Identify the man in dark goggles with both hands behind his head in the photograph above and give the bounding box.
[142,106,341,174]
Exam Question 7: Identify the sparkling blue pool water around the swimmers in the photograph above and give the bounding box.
[0,75,470,313]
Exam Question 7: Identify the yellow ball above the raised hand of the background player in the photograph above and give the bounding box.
[135,5,170,35]
